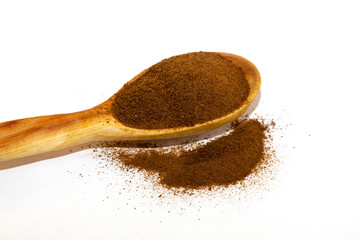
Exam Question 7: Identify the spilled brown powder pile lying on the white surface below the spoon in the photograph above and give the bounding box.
[95,119,275,189]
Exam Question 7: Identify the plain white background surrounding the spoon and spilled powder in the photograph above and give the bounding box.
[0,0,360,240]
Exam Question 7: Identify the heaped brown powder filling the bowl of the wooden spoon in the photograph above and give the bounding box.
[113,52,250,129]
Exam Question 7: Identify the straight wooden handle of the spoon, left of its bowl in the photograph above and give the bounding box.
[0,110,96,161]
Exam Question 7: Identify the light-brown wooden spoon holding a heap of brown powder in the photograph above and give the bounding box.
[0,53,261,160]
